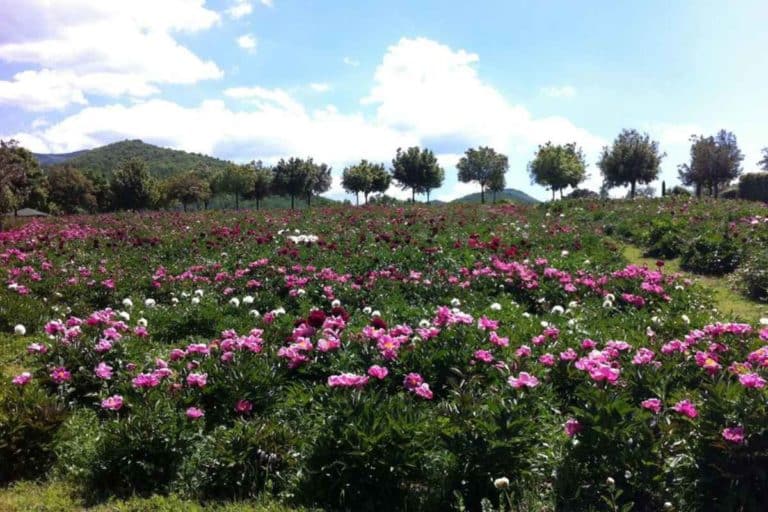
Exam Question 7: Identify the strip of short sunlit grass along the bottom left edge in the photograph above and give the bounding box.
[0,482,309,512]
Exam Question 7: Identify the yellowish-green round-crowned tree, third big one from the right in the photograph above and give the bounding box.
[528,142,587,201]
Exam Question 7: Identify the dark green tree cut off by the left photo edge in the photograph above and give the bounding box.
[0,139,47,213]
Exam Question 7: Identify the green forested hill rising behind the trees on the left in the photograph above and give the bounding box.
[35,140,229,178]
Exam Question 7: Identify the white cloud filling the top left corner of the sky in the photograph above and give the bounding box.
[0,0,222,110]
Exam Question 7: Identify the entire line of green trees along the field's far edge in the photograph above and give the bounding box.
[0,130,768,213]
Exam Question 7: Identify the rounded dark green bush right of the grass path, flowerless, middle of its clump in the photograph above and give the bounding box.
[680,233,741,275]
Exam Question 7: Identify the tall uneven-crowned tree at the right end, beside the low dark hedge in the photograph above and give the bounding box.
[678,130,744,197]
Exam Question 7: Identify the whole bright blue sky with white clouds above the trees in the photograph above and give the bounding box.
[0,0,768,200]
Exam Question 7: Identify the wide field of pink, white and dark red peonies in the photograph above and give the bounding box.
[0,200,768,511]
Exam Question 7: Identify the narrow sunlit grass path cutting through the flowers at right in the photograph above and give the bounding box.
[622,245,768,323]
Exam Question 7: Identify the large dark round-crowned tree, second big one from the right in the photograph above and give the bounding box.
[597,130,666,198]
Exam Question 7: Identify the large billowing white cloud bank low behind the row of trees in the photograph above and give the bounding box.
[11,39,605,199]
